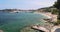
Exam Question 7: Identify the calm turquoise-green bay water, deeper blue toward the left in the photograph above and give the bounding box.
[0,12,46,32]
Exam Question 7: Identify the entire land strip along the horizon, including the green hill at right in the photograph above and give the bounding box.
[0,6,58,14]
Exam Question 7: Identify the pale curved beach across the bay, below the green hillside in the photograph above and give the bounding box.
[34,12,57,22]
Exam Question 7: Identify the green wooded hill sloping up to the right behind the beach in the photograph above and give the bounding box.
[37,6,58,14]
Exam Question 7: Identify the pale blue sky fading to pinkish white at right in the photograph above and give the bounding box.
[0,0,56,9]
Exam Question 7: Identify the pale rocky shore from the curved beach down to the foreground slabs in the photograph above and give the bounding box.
[32,12,57,32]
